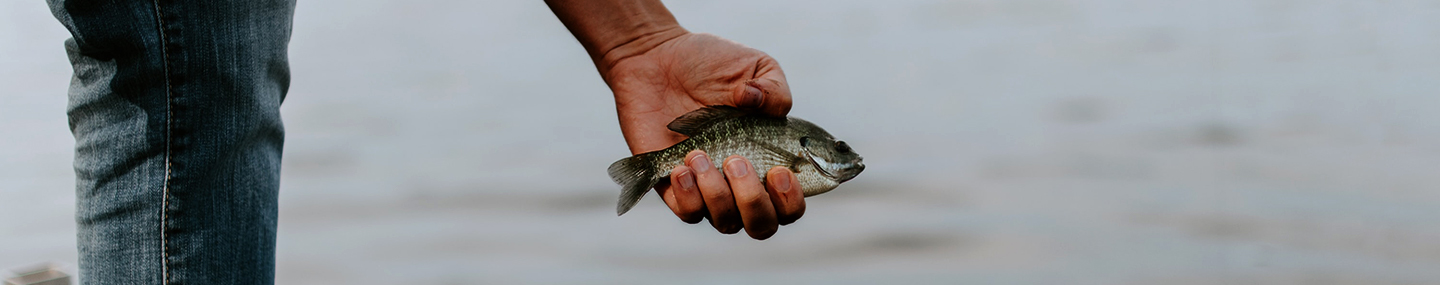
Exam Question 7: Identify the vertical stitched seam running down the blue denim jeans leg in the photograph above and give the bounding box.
[153,0,174,284]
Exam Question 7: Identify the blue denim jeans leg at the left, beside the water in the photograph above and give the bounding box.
[50,0,295,284]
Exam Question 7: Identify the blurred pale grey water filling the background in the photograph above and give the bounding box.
[0,0,1440,284]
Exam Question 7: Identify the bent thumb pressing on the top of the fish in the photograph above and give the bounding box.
[734,56,792,117]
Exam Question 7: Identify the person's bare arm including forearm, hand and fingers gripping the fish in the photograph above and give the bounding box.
[546,0,805,239]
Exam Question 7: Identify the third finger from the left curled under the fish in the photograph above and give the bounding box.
[724,155,780,239]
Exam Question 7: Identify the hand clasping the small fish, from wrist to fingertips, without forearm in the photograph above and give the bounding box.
[602,33,805,239]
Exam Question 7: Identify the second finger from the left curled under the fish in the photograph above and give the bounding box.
[685,150,743,235]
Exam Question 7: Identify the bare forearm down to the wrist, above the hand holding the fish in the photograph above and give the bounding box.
[546,0,687,76]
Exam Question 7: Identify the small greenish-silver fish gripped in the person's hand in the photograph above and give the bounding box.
[609,105,865,214]
